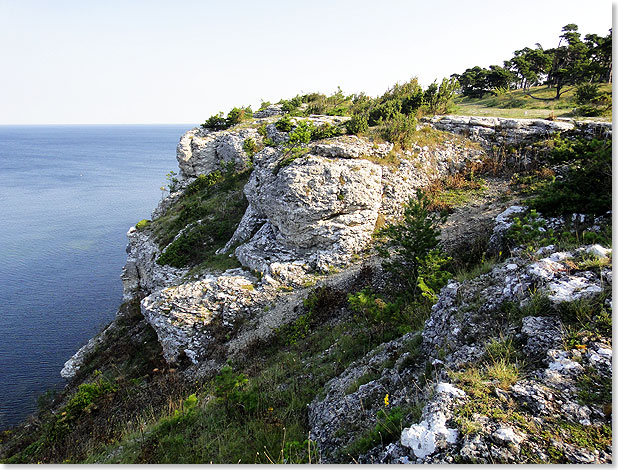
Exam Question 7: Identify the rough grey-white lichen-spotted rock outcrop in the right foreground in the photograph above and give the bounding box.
[309,208,612,463]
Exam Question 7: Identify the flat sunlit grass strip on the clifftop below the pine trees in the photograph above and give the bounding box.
[452,84,611,121]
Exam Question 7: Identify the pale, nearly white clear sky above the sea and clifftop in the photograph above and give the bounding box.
[0,0,613,124]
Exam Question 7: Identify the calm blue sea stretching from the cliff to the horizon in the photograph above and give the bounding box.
[0,125,191,429]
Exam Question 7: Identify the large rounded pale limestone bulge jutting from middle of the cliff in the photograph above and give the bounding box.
[228,148,382,275]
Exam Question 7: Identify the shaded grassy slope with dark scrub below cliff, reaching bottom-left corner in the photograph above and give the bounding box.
[7,289,416,463]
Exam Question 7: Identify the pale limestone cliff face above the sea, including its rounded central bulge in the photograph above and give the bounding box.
[107,116,482,375]
